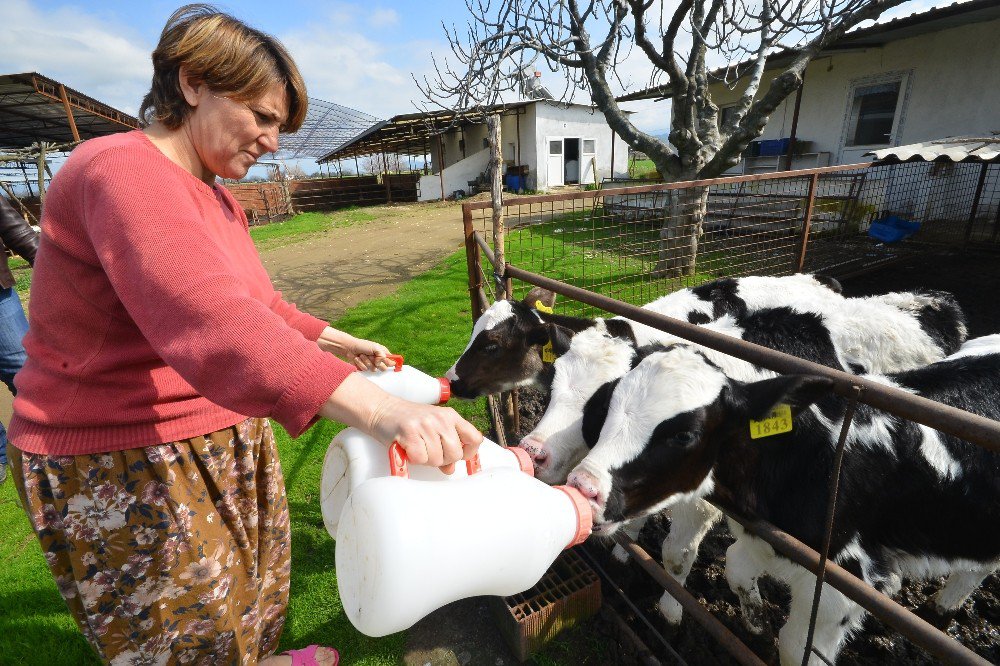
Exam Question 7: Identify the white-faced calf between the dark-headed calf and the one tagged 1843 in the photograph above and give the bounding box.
[521,284,966,483]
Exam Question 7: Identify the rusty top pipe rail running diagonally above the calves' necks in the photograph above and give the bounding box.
[506,264,1000,452]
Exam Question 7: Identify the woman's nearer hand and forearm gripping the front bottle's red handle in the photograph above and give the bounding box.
[319,374,483,474]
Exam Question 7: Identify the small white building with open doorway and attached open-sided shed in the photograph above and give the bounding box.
[320,99,628,201]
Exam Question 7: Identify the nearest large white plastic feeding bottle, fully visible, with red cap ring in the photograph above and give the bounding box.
[336,445,593,637]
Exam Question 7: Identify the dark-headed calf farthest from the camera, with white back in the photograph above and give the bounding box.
[446,274,852,398]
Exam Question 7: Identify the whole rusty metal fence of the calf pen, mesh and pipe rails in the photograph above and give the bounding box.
[463,163,1000,664]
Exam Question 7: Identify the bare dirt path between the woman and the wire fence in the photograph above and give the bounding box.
[261,202,463,321]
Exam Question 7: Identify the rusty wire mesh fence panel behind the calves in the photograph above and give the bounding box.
[465,162,1000,313]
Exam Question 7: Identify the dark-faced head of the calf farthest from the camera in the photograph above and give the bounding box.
[445,289,572,399]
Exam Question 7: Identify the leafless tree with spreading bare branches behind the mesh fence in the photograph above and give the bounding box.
[421,0,905,275]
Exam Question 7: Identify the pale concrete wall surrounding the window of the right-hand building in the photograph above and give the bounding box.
[712,21,1000,164]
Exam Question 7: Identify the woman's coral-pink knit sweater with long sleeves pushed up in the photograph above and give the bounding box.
[9,131,353,455]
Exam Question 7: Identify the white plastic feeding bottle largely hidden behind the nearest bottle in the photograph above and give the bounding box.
[319,428,535,539]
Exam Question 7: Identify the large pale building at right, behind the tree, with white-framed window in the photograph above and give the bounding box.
[620,0,1000,173]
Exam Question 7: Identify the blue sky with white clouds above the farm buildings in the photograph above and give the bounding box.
[0,0,945,150]
